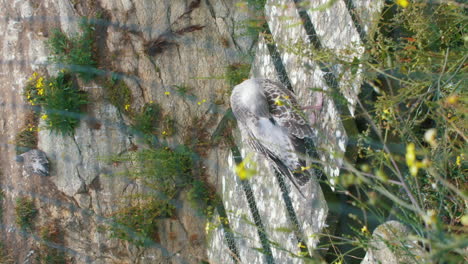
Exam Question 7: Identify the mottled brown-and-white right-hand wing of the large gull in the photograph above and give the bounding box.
[260,79,312,139]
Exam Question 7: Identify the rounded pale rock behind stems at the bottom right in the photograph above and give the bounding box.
[361,221,426,264]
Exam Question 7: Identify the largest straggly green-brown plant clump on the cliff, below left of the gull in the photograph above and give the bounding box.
[110,146,194,245]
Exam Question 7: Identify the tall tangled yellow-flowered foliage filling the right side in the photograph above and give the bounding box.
[300,2,468,263]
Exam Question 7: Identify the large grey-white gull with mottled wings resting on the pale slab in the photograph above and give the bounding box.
[231,79,312,192]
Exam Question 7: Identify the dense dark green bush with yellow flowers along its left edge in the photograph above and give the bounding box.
[41,71,88,135]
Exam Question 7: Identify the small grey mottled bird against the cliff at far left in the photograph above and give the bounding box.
[18,149,49,177]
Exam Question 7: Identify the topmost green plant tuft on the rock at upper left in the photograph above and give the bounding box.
[47,18,97,81]
